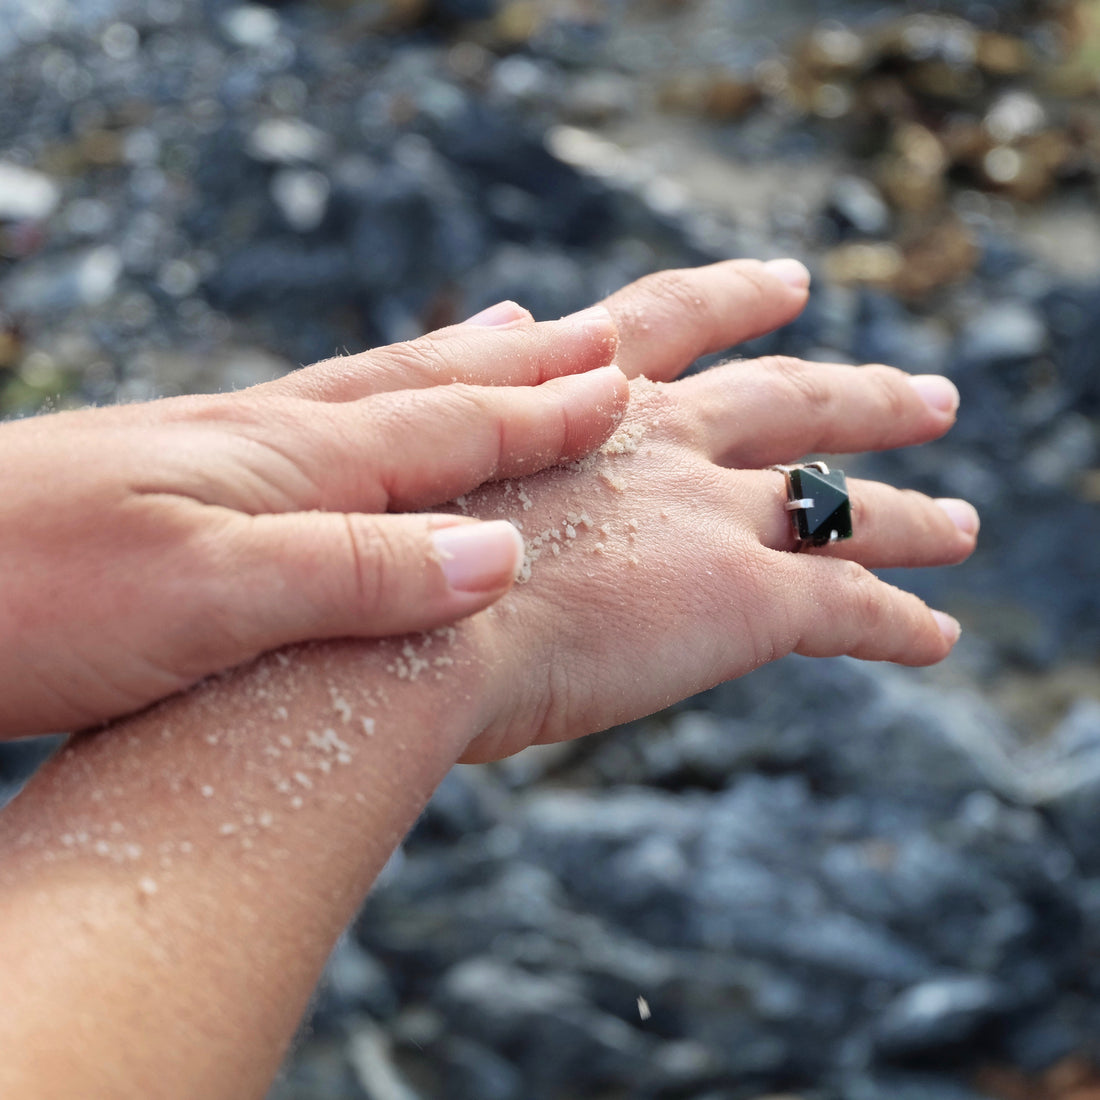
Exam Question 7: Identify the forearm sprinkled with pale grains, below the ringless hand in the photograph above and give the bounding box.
[0,622,483,1100]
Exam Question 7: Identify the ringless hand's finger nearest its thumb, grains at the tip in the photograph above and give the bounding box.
[257,366,629,512]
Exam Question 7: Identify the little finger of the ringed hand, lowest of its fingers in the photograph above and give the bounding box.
[774,554,959,664]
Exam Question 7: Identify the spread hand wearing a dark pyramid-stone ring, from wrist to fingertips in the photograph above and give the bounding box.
[453,264,978,762]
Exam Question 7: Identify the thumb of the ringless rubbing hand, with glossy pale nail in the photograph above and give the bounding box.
[204,512,532,651]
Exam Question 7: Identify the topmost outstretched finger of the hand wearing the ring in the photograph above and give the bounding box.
[604,260,810,382]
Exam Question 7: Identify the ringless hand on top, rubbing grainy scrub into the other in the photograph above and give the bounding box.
[0,304,626,737]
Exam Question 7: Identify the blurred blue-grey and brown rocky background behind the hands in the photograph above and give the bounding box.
[0,0,1100,1100]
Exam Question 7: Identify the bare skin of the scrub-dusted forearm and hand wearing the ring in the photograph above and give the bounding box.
[0,263,977,1098]
